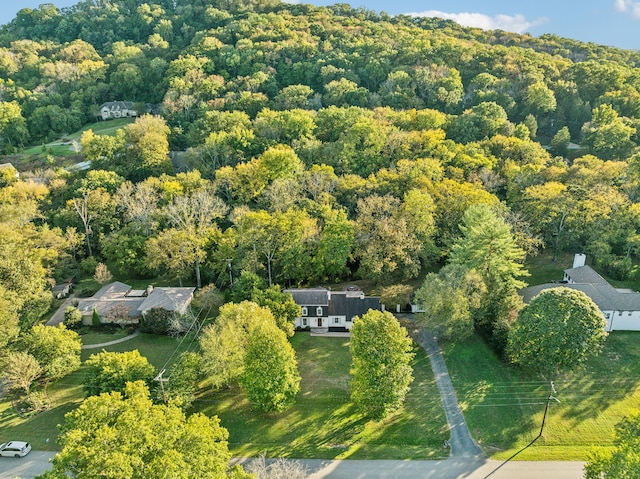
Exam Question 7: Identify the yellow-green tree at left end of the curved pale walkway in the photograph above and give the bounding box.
[22,324,82,380]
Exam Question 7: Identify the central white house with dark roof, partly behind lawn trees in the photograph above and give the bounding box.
[284,288,384,332]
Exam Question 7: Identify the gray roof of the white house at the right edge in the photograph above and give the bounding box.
[520,266,640,311]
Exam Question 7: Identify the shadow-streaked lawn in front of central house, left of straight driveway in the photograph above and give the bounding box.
[194,332,449,459]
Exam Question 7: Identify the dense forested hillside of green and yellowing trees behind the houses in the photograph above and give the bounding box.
[0,0,640,340]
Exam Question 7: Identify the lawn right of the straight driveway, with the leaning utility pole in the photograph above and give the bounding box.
[443,332,640,460]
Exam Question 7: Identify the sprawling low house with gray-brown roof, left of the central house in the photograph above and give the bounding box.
[78,281,195,324]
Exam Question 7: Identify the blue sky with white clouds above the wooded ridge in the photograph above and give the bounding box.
[0,0,640,50]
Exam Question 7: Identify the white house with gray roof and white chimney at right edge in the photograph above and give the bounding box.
[520,255,640,331]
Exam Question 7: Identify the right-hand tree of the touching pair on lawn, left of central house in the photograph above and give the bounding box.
[240,322,300,412]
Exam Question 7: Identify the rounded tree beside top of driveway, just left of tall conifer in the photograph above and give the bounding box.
[415,264,487,341]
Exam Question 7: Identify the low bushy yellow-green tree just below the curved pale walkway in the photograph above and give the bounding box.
[82,349,155,396]
